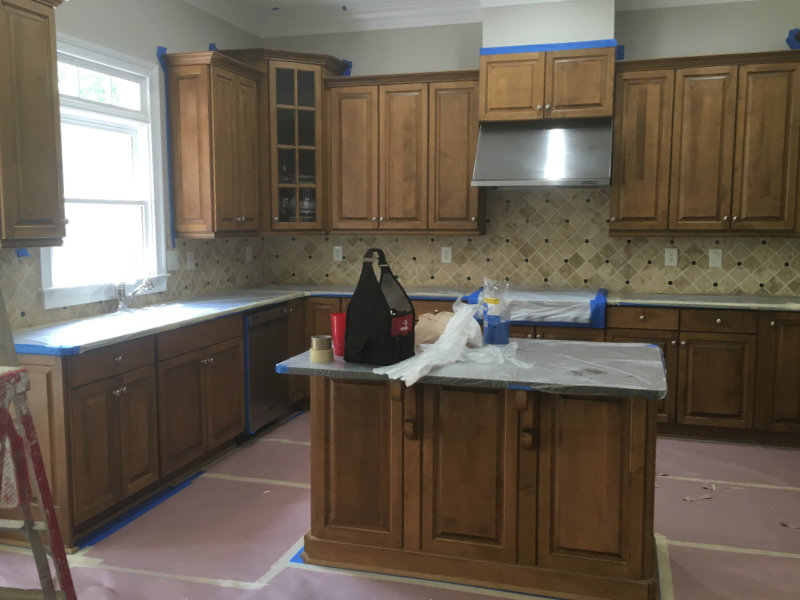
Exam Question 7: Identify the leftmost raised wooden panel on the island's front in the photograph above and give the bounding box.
[311,377,403,548]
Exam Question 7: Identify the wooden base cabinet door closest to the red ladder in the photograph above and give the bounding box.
[70,377,122,524]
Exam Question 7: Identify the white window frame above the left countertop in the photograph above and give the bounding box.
[41,34,169,309]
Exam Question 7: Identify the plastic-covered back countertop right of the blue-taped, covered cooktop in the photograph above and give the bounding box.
[606,292,800,312]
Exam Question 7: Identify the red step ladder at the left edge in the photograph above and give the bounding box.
[0,367,77,600]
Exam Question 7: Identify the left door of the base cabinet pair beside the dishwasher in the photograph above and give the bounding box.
[158,350,206,476]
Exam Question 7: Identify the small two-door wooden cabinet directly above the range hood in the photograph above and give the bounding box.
[480,48,616,121]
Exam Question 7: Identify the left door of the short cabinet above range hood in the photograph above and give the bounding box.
[479,52,545,121]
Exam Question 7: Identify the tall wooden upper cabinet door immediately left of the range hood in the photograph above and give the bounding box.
[428,81,483,231]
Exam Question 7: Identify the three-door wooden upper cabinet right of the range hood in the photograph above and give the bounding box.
[609,52,800,235]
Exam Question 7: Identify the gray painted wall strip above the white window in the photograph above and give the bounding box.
[56,0,261,63]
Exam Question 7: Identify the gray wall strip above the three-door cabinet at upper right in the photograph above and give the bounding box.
[616,0,800,59]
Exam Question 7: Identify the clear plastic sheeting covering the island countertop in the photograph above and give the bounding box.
[275,339,667,398]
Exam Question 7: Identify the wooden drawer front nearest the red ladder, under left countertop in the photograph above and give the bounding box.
[69,335,155,387]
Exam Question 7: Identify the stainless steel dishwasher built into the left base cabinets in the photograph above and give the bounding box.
[245,304,290,433]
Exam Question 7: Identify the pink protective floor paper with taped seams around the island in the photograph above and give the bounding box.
[0,413,800,600]
